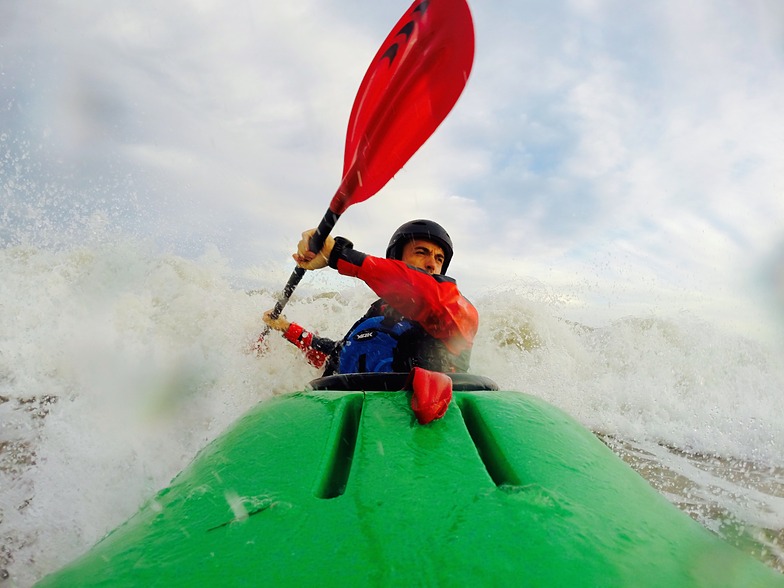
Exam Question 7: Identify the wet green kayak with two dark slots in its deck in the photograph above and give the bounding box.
[39,374,784,588]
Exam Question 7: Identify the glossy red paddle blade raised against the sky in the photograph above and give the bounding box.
[329,0,474,214]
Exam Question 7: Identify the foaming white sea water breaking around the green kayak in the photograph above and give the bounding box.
[0,241,784,586]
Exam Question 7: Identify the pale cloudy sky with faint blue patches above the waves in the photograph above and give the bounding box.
[0,0,784,334]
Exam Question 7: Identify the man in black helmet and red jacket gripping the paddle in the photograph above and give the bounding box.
[264,219,479,376]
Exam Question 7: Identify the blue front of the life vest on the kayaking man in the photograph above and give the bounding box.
[339,315,414,374]
